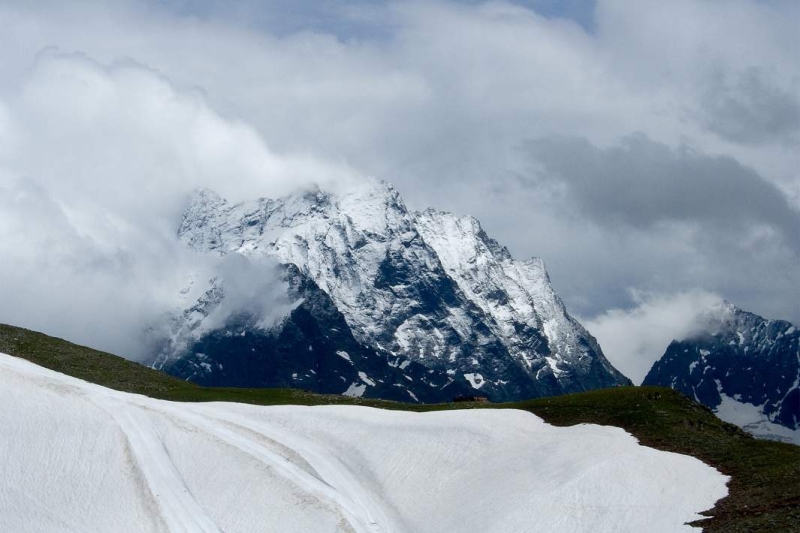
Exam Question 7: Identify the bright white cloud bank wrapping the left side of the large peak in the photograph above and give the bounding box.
[0,50,358,358]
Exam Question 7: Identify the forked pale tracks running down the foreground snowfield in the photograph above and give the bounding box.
[87,390,393,533]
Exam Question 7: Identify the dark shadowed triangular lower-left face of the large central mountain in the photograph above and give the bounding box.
[162,265,472,402]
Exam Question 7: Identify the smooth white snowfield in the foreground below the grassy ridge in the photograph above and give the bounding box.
[0,354,728,533]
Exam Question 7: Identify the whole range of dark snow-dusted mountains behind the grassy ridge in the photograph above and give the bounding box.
[151,181,800,443]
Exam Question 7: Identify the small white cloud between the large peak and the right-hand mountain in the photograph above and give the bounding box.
[583,290,723,385]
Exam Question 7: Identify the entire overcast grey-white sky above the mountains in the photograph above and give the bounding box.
[0,0,800,381]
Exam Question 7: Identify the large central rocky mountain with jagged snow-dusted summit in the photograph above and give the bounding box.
[156,181,630,401]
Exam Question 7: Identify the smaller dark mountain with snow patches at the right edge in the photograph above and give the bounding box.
[643,302,800,444]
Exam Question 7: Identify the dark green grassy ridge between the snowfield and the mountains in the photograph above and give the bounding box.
[0,325,800,532]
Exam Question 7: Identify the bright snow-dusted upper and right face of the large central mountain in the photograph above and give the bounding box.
[169,181,629,400]
